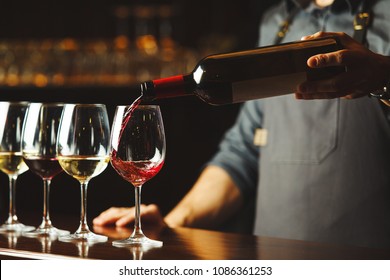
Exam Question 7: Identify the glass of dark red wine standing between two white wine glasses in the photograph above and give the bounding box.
[22,103,69,237]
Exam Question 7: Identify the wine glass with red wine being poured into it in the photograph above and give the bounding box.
[111,103,166,247]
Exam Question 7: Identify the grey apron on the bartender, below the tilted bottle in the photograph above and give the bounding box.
[254,95,390,247]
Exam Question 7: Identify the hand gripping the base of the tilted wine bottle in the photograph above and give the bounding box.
[296,32,390,99]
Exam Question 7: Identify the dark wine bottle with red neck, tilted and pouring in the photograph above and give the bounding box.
[140,37,345,105]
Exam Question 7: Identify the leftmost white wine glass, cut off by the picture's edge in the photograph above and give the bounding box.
[0,102,35,232]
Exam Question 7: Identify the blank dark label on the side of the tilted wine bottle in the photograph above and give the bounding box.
[232,72,307,103]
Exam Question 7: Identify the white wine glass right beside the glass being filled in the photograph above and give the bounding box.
[57,104,110,243]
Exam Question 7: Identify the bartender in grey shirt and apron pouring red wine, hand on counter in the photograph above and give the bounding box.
[94,0,390,248]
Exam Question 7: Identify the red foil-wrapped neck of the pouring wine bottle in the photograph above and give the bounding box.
[141,74,193,101]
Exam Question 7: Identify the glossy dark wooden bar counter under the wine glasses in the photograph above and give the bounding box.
[0,215,390,260]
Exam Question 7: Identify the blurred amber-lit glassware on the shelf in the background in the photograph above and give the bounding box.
[0,0,199,87]
